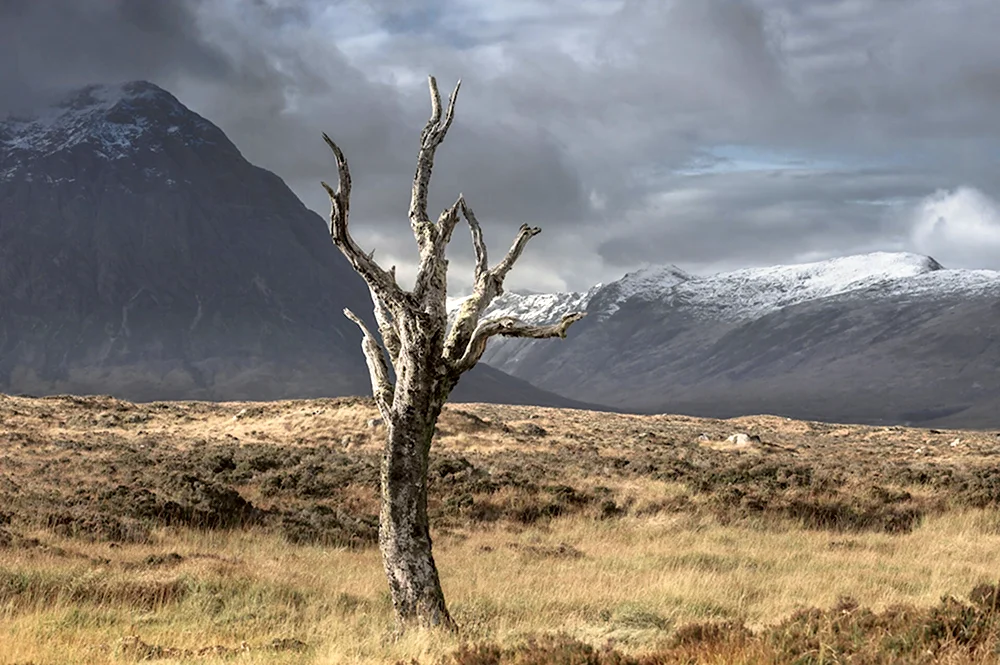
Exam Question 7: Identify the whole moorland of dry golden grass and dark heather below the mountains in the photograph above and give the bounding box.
[0,396,1000,665]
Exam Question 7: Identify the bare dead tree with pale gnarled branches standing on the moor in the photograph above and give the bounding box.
[322,76,583,629]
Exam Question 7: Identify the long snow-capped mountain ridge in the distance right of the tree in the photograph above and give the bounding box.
[458,253,1000,427]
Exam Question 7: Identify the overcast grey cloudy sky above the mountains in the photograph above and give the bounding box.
[0,0,1000,293]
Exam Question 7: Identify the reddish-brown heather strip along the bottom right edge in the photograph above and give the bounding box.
[439,585,1000,665]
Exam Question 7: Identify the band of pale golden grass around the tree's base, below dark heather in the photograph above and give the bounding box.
[0,510,1000,665]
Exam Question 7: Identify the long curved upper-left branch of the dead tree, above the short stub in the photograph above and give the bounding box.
[320,133,406,314]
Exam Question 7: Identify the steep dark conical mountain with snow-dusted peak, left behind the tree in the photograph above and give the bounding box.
[0,82,592,406]
